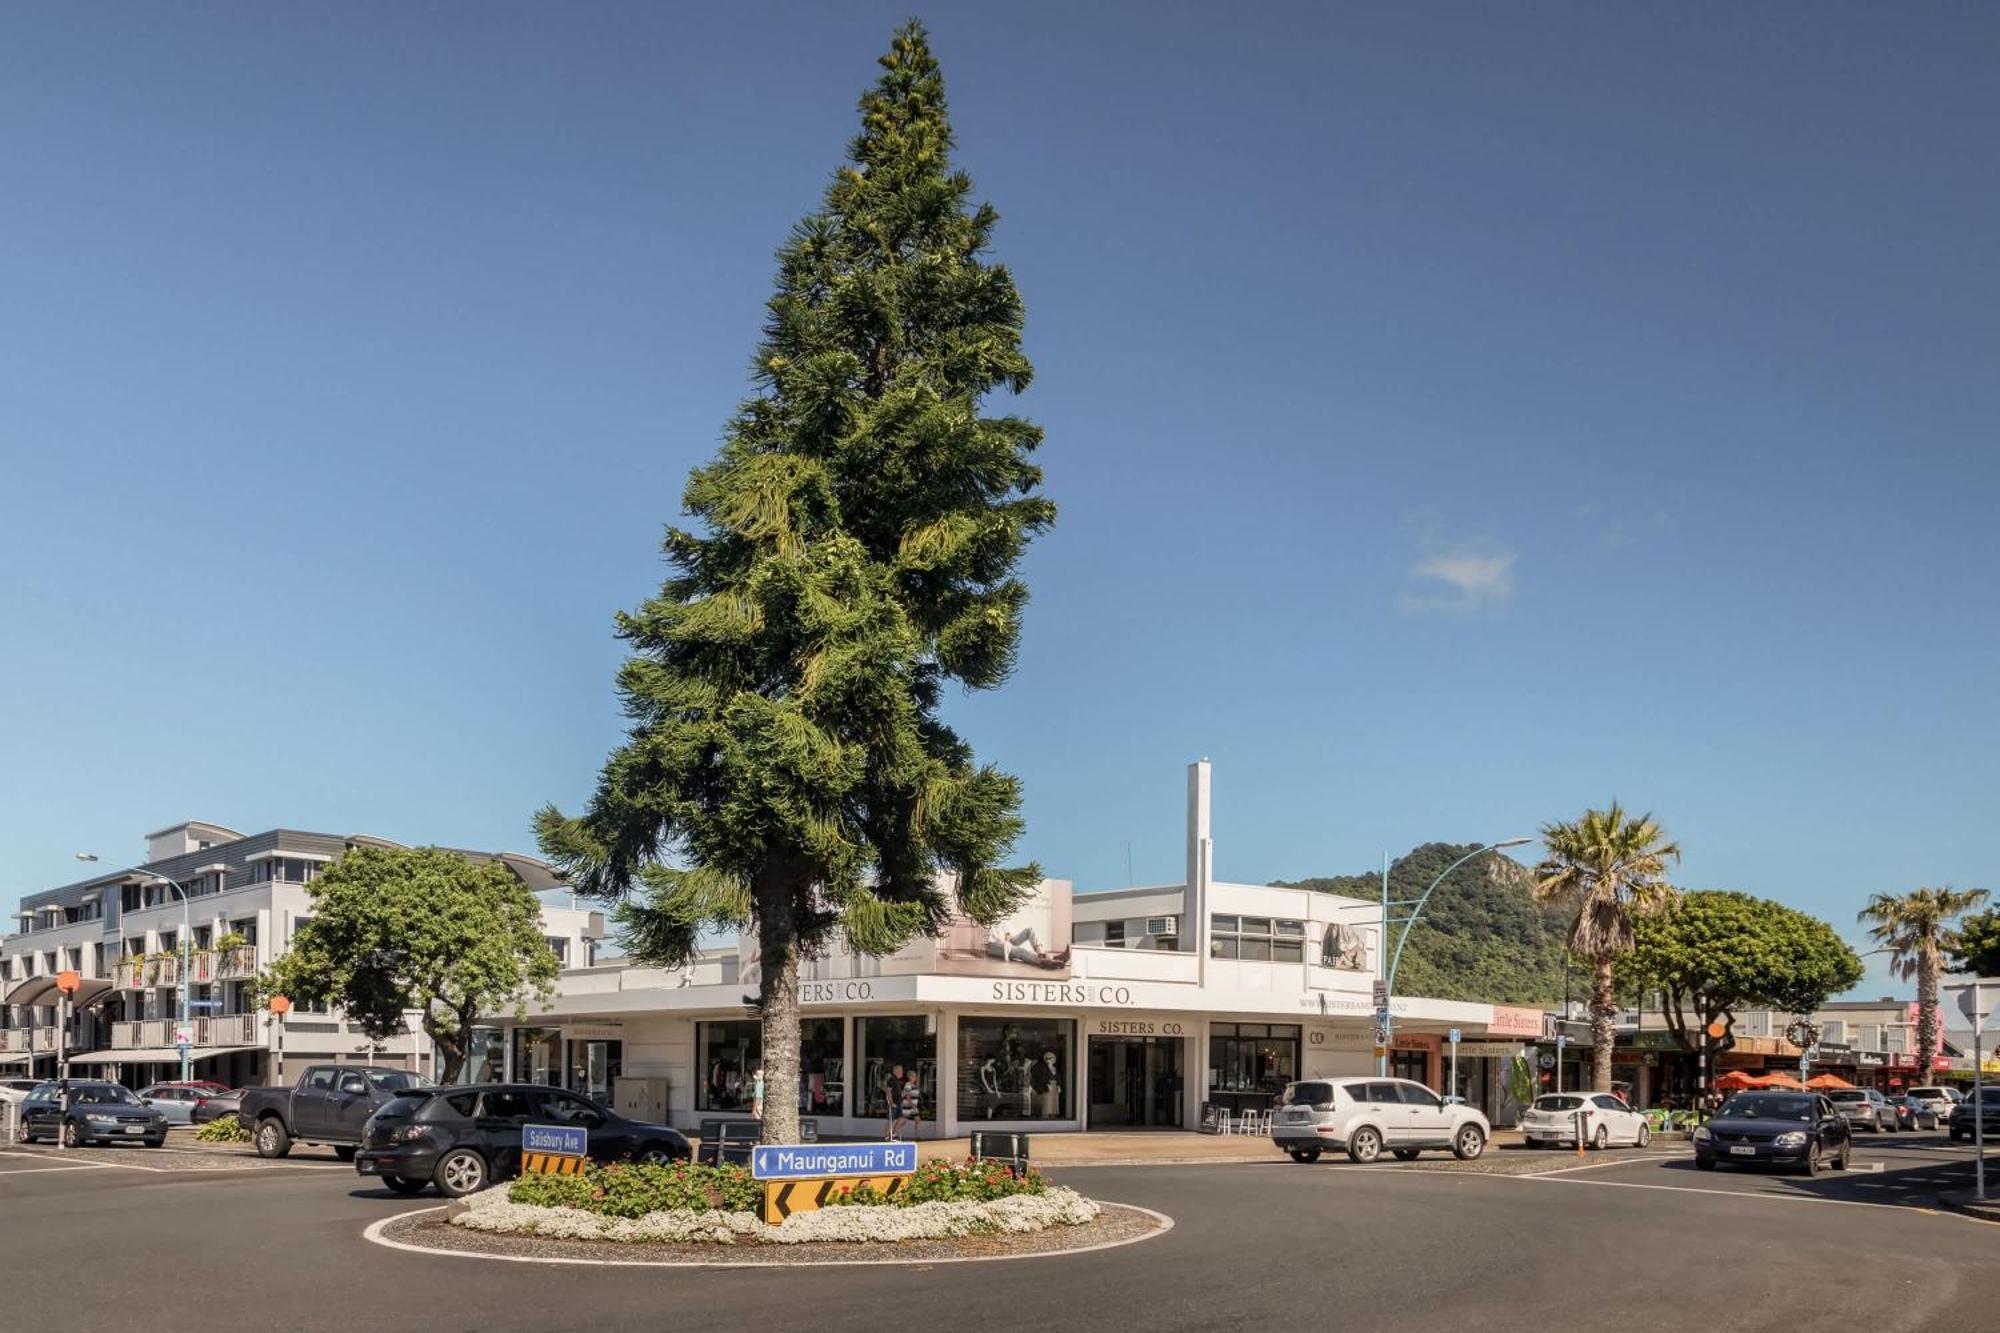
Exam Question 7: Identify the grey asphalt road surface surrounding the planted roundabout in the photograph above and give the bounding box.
[0,1135,2000,1333]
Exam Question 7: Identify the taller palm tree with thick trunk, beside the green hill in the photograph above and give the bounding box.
[1534,801,1680,1093]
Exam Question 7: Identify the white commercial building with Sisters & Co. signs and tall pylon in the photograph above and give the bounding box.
[482,761,1542,1137]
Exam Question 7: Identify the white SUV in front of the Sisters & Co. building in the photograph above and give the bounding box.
[1270,1079,1492,1163]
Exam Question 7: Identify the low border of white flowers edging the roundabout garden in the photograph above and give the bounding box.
[450,1185,1102,1245]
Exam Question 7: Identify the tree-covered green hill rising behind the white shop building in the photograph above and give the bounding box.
[1276,843,1588,1009]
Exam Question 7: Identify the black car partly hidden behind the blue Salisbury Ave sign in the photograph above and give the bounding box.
[354,1083,690,1199]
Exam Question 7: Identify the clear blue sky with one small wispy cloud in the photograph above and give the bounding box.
[0,0,2000,993]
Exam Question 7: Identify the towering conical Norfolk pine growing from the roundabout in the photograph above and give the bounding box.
[538,22,1056,1143]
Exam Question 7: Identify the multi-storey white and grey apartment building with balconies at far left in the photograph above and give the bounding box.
[0,821,604,1087]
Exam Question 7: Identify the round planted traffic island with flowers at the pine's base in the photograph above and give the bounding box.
[370,1161,1172,1265]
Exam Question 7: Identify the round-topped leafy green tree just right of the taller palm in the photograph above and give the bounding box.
[1618,889,1862,1059]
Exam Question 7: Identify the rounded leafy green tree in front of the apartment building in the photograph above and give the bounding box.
[258,847,562,1083]
